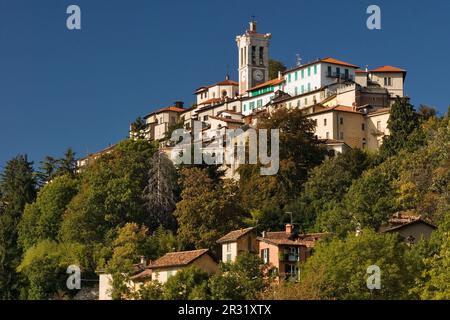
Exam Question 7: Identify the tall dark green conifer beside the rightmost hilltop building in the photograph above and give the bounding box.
[380,97,420,157]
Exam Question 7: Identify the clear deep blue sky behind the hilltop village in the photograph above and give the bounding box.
[0,0,450,168]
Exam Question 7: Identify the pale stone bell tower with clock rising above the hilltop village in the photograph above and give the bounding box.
[236,20,272,95]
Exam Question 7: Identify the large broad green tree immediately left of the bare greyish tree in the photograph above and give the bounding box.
[60,140,155,243]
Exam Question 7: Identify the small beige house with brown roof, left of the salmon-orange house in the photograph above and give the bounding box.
[217,227,258,262]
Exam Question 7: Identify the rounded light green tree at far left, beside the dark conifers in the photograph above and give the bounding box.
[18,175,78,250]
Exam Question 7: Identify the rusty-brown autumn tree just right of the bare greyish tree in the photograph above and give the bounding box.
[174,168,244,249]
